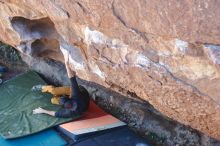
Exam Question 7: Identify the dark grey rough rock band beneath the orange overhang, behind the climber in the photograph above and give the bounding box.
[15,56,220,146]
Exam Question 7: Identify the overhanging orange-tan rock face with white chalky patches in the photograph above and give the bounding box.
[0,0,220,139]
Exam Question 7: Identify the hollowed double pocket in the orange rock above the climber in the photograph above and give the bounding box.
[11,17,61,57]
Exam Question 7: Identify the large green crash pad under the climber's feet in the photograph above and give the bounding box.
[0,71,80,139]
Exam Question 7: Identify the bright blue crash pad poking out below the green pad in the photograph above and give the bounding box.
[0,129,66,146]
